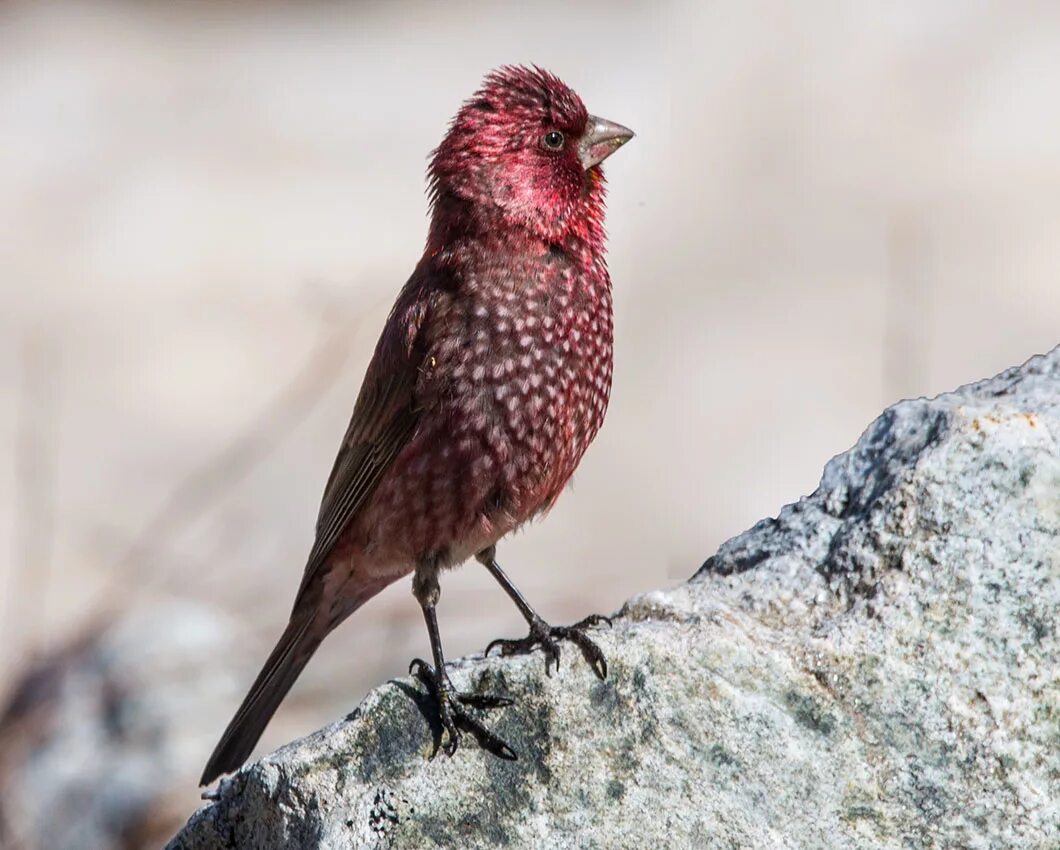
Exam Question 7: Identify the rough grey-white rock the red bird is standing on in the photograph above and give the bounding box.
[170,349,1060,850]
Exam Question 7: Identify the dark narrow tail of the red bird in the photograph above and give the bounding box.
[199,617,323,785]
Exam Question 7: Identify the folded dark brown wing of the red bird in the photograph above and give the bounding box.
[295,276,429,610]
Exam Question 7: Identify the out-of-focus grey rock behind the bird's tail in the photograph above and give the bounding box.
[0,598,245,850]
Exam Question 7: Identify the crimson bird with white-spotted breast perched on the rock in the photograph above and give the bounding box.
[201,67,633,784]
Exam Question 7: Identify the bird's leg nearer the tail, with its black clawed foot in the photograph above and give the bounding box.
[408,564,516,759]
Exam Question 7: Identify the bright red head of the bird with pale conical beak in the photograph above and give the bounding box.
[430,67,633,240]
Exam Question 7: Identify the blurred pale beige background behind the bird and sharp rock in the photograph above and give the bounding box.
[0,0,1060,850]
